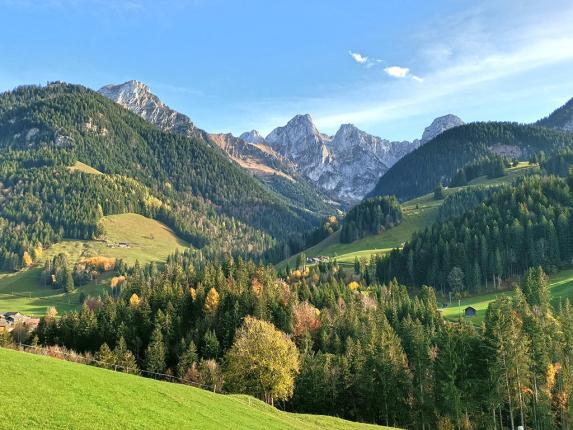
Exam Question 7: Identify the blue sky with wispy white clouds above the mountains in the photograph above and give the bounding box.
[0,0,573,140]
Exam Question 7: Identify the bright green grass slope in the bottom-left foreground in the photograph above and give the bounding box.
[0,348,392,430]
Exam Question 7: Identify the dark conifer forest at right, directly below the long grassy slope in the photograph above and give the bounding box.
[375,176,573,294]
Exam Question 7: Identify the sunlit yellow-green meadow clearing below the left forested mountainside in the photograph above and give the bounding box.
[0,214,187,315]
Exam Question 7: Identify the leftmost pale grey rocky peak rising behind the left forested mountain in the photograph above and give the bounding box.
[98,81,200,136]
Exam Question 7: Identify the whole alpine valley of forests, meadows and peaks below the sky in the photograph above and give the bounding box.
[0,70,573,429]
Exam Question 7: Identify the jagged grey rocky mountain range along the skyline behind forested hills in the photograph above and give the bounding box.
[99,81,463,206]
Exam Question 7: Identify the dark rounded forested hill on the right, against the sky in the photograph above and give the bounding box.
[370,122,573,200]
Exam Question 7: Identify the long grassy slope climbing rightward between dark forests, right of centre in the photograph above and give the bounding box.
[278,162,533,268]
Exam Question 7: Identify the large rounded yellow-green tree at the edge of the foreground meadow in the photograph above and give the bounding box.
[225,317,300,405]
